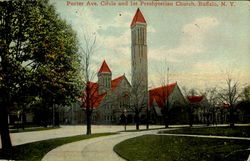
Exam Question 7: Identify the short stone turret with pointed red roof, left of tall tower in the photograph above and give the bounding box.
[97,60,112,94]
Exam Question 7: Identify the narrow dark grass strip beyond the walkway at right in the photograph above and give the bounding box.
[160,126,250,137]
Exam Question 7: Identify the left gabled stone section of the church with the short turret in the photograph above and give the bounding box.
[82,60,131,124]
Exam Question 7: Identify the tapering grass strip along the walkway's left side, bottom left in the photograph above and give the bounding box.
[0,133,115,161]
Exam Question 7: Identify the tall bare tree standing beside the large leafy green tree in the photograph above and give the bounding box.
[80,34,99,135]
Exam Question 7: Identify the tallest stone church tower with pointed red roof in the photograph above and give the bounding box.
[130,8,148,104]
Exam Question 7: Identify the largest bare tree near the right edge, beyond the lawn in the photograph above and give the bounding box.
[218,74,241,127]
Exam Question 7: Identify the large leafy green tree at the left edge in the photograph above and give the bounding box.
[0,0,81,149]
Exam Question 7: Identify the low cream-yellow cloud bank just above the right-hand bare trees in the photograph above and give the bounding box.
[149,62,250,90]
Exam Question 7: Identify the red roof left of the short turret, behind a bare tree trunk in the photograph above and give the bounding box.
[82,82,106,108]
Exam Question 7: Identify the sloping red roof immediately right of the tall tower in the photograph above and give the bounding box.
[149,83,177,108]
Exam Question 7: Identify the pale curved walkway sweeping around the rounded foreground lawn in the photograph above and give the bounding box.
[42,129,250,161]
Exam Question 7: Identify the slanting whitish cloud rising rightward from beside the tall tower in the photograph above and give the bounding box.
[149,17,219,62]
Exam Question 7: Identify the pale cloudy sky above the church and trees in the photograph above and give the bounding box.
[51,0,250,90]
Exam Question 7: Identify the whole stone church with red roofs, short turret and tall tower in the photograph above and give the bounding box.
[78,8,186,124]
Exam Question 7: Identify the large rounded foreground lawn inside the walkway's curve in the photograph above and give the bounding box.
[114,135,250,161]
